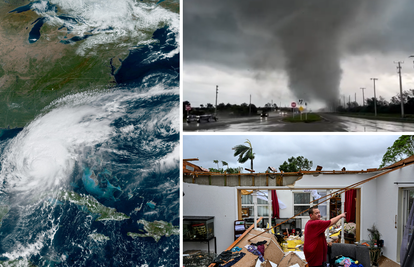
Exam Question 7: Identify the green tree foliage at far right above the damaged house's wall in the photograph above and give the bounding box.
[380,135,414,168]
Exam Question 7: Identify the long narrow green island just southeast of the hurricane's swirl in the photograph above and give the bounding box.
[58,191,130,221]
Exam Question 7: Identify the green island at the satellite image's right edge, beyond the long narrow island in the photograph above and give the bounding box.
[127,220,180,242]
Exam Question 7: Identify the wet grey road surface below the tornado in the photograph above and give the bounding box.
[183,114,414,132]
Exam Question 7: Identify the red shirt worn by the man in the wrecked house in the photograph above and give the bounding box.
[303,220,331,266]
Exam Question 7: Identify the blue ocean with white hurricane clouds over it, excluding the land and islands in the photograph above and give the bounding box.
[0,7,180,266]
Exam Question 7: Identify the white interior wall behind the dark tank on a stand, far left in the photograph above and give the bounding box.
[183,183,237,254]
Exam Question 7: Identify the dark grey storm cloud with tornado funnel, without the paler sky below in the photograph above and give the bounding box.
[183,0,414,107]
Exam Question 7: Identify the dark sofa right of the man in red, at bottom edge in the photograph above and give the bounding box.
[328,243,371,267]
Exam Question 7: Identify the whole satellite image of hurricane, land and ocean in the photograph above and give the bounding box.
[0,0,180,266]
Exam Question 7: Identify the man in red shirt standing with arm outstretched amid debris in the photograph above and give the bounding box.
[303,206,346,267]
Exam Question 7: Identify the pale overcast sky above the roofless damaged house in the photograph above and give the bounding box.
[183,134,400,172]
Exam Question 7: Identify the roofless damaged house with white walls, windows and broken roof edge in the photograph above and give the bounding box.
[183,156,414,264]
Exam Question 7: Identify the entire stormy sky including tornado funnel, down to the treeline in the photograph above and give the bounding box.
[182,0,414,109]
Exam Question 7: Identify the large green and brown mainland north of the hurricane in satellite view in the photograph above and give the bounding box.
[0,0,179,128]
